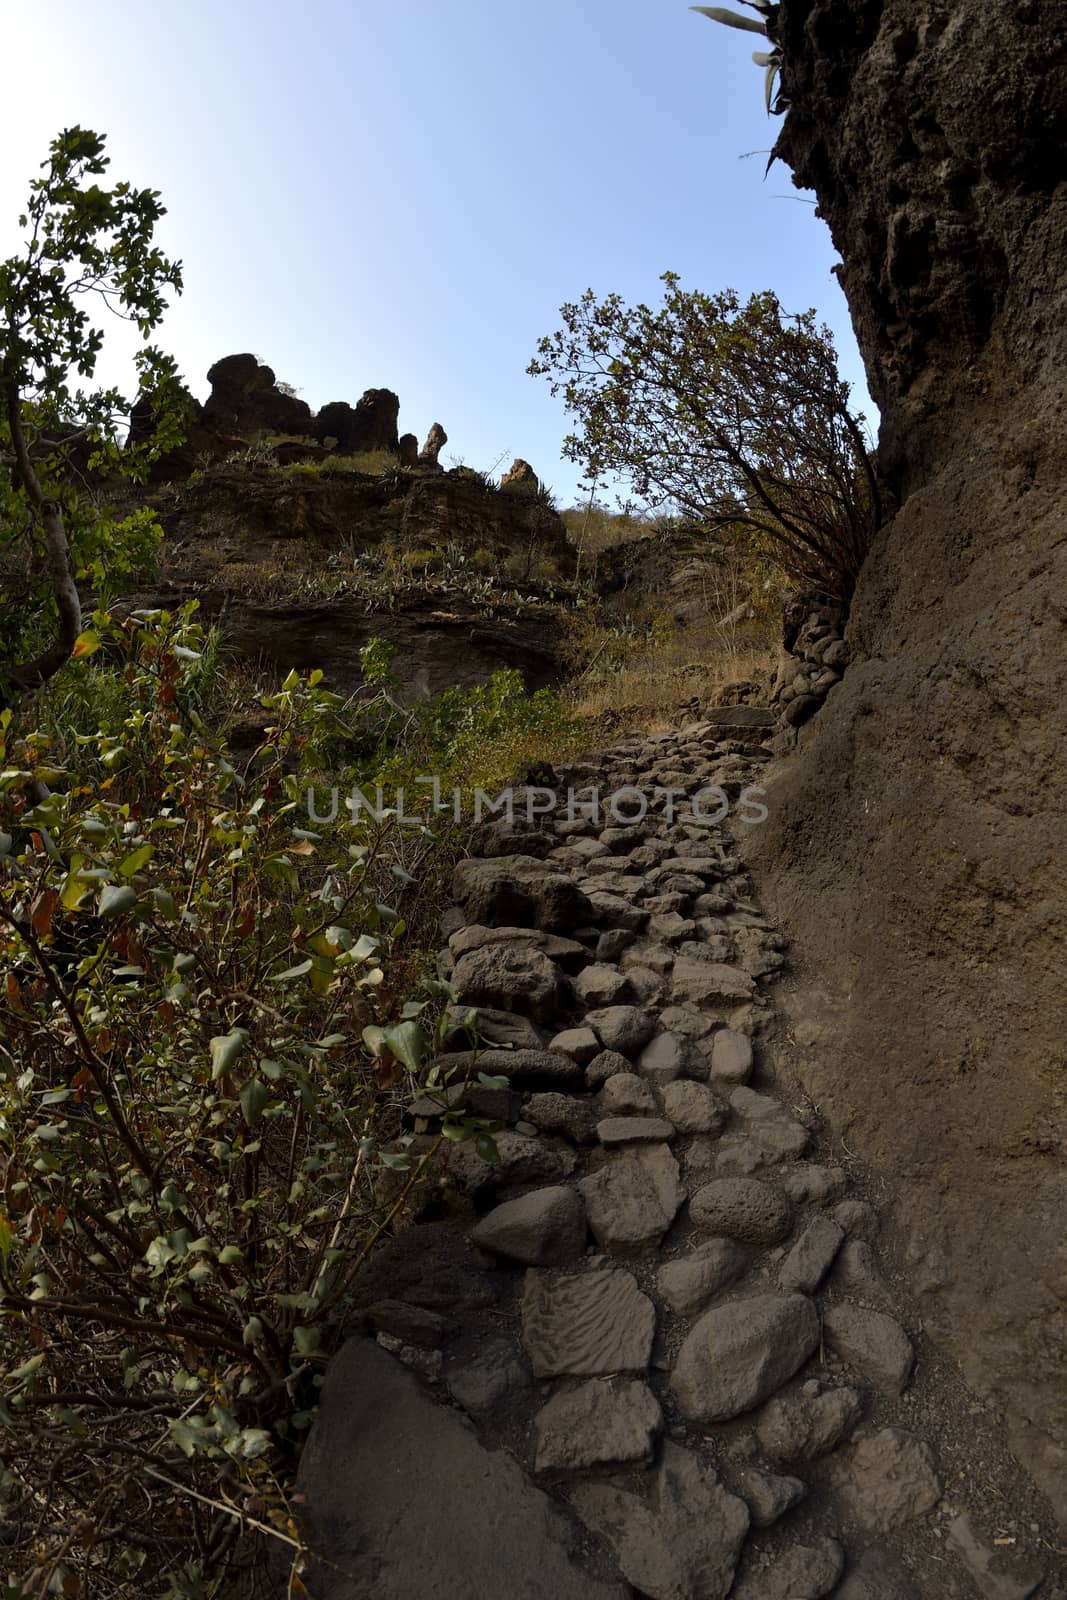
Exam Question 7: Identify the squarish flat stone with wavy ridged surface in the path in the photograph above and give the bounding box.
[522,1267,656,1378]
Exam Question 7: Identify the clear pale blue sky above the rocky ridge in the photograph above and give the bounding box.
[0,0,873,502]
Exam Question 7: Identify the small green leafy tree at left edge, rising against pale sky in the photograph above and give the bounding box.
[0,128,186,702]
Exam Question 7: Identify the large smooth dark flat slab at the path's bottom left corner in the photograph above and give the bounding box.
[294,1339,627,1600]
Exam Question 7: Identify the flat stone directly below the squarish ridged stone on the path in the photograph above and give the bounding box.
[534,1378,664,1472]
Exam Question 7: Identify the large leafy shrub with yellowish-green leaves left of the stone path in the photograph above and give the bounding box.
[0,611,501,1600]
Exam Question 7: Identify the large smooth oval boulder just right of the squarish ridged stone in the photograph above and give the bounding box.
[670,1294,819,1422]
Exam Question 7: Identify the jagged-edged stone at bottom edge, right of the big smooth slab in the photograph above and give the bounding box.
[571,1440,749,1600]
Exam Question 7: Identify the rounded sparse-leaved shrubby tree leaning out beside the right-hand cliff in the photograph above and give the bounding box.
[530,272,880,600]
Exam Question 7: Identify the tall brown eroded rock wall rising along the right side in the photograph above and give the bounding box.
[752,0,1067,1520]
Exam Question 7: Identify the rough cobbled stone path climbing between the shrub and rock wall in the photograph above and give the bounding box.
[301,723,1067,1600]
